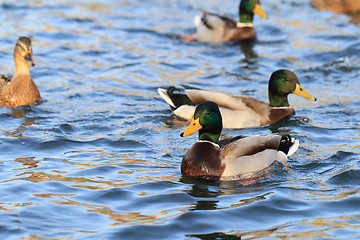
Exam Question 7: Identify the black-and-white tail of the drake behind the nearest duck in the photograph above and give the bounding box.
[158,86,195,109]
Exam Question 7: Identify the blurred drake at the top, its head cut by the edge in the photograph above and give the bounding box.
[184,0,267,43]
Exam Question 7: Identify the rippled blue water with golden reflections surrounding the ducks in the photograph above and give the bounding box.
[0,0,360,239]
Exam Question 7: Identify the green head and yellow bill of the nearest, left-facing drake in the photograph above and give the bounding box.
[180,102,222,143]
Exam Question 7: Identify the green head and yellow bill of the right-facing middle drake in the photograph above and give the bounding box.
[268,69,316,107]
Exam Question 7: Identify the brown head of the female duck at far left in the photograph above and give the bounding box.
[14,37,35,67]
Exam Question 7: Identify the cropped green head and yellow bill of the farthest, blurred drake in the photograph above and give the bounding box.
[239,0,267,23]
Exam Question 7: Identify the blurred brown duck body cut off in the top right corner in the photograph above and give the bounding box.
[311,0,360,13]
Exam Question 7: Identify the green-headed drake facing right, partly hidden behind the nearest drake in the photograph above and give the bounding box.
[158,70,316,128]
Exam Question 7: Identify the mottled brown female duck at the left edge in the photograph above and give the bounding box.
[0,37,40,107]
